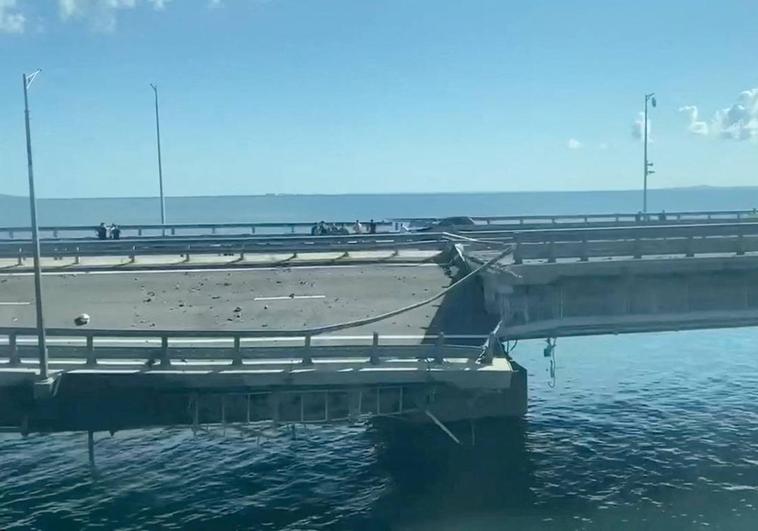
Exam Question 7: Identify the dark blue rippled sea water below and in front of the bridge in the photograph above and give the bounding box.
[0,329,758,531]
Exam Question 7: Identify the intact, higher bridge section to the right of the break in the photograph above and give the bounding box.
[464,223,758,339]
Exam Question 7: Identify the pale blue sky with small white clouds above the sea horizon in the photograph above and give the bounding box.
[0,0,758,197]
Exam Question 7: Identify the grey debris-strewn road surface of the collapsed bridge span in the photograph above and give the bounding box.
[0,264,491,335]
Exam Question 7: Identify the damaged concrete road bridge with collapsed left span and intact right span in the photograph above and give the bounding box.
[0,210,758,450]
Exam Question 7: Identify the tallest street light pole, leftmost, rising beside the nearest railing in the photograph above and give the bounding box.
[23,70,48,380]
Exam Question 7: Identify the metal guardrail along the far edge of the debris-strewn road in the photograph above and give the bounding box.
[0,233,449,262]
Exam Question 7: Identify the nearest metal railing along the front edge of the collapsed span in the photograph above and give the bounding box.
[0,327,481,368]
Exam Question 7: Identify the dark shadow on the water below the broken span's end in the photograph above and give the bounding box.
[360,419,534,529]
